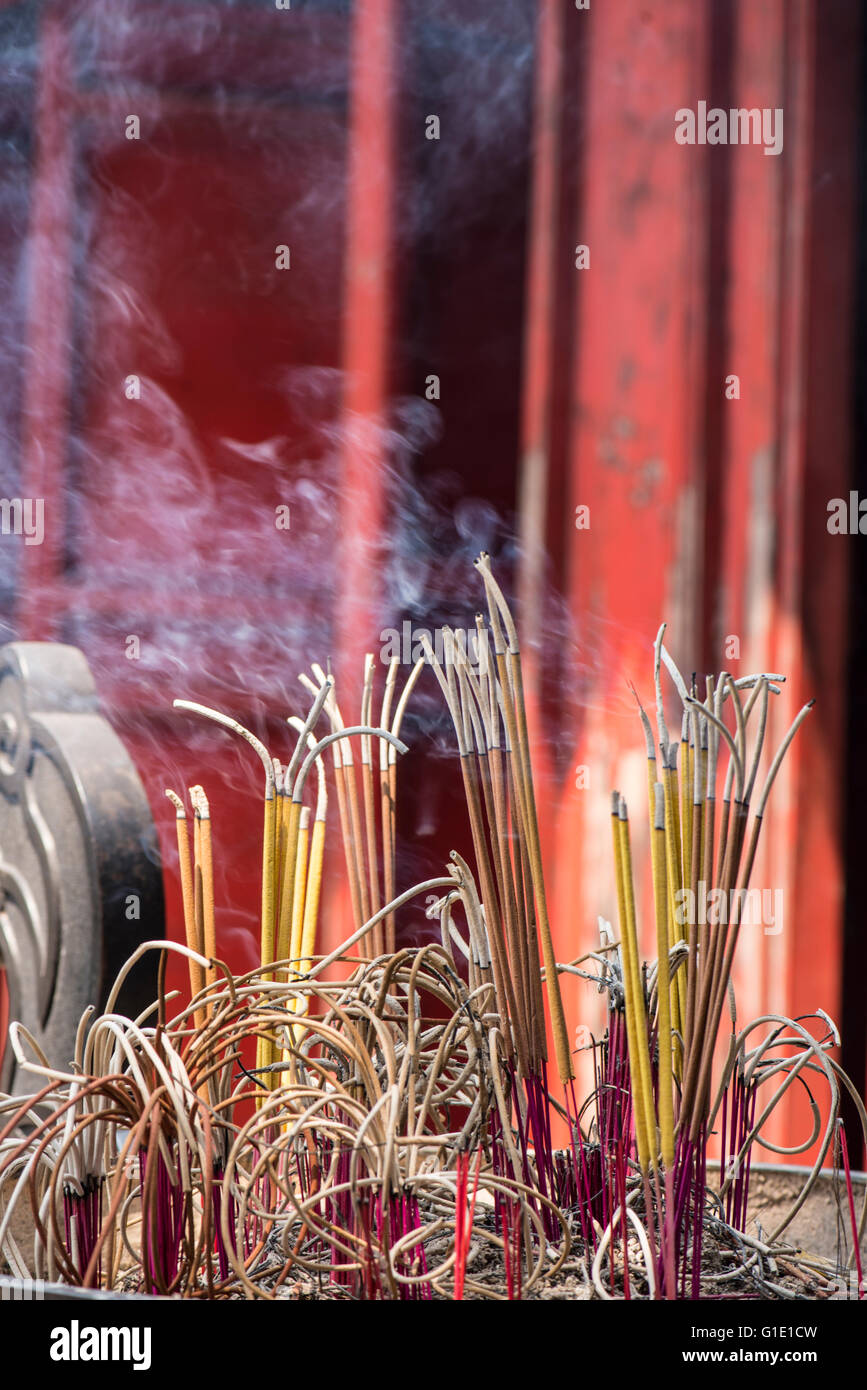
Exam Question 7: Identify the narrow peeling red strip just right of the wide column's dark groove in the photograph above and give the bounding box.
[706,0,789,1056]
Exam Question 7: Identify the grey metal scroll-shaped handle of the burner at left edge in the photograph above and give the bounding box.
[0,642,164,1094]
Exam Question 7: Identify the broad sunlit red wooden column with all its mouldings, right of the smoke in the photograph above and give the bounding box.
[544,0,861,1144]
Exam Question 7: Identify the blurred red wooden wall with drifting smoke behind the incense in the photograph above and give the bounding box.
[0,0,867,1162]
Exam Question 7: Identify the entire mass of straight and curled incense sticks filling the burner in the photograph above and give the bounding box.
[0,555,867,1298]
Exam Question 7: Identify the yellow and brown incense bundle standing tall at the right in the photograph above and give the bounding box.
[611,626,813,1169]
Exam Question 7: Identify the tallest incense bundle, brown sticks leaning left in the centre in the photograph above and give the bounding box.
[422,553,572,1084]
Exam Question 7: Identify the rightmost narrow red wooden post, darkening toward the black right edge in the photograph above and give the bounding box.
[771,0,864,1143]
